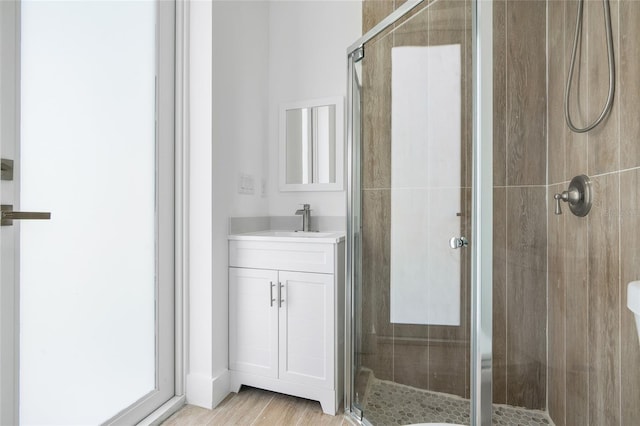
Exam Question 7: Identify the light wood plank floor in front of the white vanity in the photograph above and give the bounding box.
[163,387,353,426]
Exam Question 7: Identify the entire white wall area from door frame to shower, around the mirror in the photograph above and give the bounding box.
[187,0,361,408]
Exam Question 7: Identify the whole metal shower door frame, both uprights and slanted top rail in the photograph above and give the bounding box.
[344,0,493,426]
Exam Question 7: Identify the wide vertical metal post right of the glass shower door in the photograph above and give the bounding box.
[471,0,493,426]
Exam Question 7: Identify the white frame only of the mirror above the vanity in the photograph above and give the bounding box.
[278,96,344,192]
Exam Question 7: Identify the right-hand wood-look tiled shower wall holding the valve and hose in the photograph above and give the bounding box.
[547,0,640,426]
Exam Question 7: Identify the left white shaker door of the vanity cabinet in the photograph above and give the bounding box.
[229,268,278,378]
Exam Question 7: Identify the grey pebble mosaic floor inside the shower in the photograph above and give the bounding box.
[362,375,553,426]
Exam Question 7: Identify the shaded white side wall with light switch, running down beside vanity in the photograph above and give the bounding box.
[212,1,269,405]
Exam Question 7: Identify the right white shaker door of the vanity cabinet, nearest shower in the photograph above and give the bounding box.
[279,271,335,389]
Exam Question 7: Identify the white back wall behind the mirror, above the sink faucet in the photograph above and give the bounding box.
[268,0,362,216]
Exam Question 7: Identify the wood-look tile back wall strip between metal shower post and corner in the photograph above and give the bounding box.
[493,0,547,409]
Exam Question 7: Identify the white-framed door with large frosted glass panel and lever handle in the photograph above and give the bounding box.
[0,0,175,425]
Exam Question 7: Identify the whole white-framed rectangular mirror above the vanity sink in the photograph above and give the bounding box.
[280,97,344,191]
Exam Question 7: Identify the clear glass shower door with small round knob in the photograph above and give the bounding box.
[350,0,472,425]
